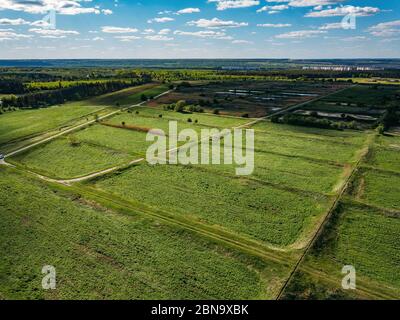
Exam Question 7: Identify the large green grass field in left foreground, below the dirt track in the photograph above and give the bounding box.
[0,168,288,300]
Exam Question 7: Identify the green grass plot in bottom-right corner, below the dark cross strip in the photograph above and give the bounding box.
[285,203,400,299]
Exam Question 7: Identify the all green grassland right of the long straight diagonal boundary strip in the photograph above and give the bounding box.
[283,130,400,299]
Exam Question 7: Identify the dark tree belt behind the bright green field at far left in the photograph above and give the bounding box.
[2,81,138,109]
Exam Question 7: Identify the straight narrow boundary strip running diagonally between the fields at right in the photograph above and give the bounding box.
[276,134,375,300]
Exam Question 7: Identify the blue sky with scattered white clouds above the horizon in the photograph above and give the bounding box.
[0,0,400,59]
